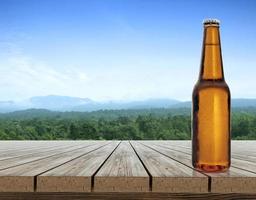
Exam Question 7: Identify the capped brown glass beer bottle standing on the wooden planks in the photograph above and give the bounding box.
[192,20,230,172]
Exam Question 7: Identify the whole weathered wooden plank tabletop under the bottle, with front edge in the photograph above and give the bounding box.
[0,140,256,199]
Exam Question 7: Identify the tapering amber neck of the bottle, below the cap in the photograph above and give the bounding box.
[199,25,224,81]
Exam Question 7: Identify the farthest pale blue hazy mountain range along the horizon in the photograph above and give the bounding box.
[0,95,256,113]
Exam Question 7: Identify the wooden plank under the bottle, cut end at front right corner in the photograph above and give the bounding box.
[142,141,256,193]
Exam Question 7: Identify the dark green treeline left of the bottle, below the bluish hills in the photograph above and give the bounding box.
[0,114,190,140]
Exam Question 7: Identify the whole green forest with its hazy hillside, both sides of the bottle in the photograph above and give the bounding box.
[0,107,256,140]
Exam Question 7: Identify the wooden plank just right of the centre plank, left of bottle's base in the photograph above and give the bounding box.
[131,141,208,193]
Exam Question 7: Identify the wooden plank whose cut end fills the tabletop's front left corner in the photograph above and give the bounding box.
[0,142,110,192]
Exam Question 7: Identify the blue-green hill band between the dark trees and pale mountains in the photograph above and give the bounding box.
[0,107,256,120]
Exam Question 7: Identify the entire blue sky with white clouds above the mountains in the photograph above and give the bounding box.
[0,0,256,101]
